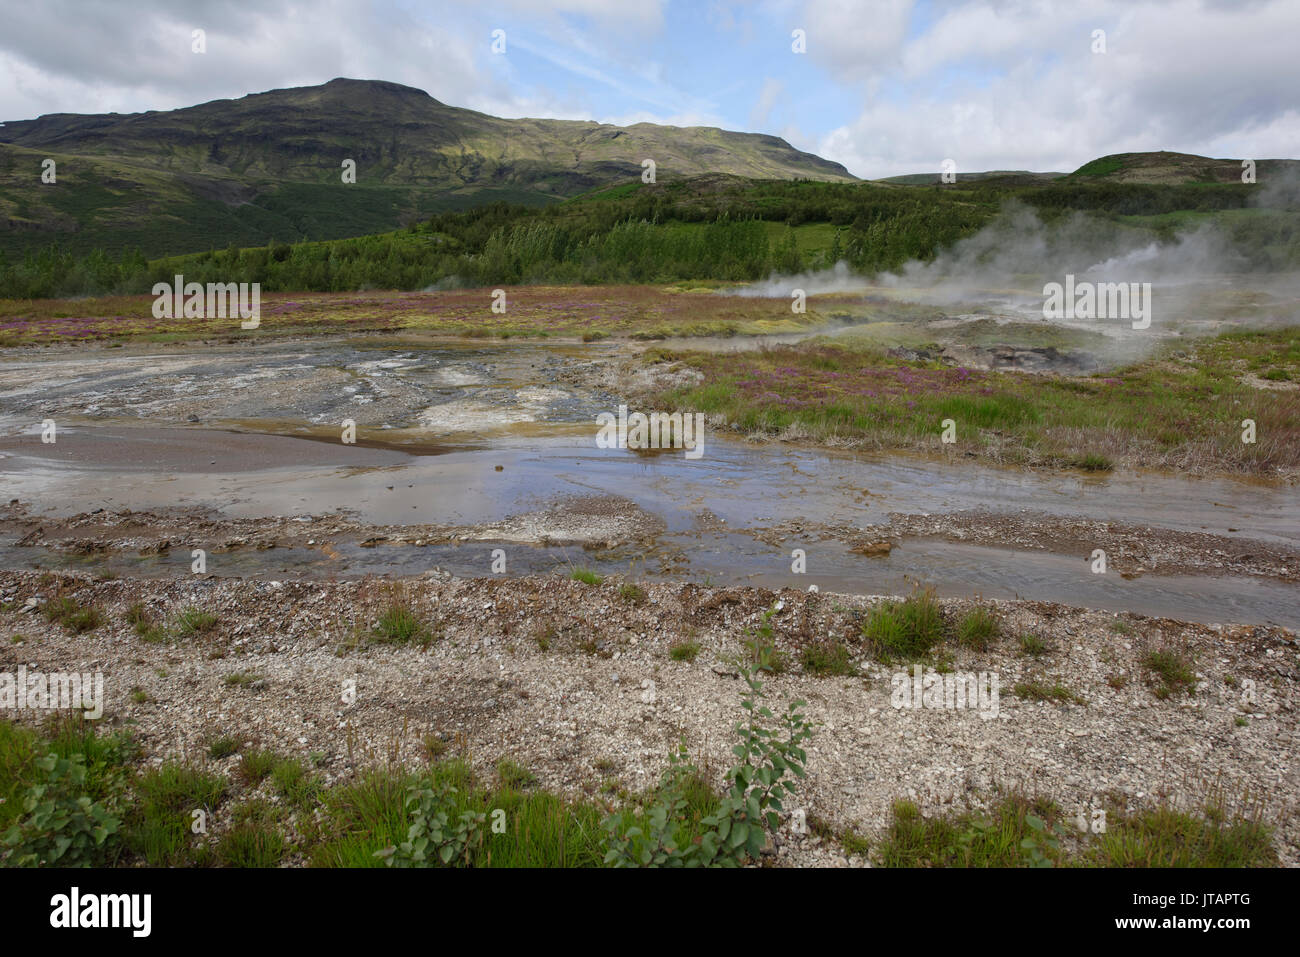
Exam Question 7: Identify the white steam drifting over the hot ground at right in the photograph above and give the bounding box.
[723,201,1300,371]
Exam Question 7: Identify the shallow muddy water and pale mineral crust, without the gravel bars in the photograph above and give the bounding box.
[0,341,1300,627]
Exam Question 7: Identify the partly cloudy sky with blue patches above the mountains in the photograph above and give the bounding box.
[0,0,1300,178]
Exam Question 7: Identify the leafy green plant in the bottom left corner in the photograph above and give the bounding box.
[4,754,121,867]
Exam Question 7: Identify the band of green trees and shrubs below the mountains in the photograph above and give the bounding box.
[0,164,1300,299]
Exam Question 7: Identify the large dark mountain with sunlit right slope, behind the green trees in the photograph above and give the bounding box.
[0,79,855,256]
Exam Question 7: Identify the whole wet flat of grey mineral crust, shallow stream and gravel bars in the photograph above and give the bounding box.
[0,332,1300,627]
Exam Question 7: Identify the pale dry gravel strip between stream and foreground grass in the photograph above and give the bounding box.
[0,572,1300,866]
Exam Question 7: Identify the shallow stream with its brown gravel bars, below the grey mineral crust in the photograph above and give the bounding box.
[0,424,1300,628]
